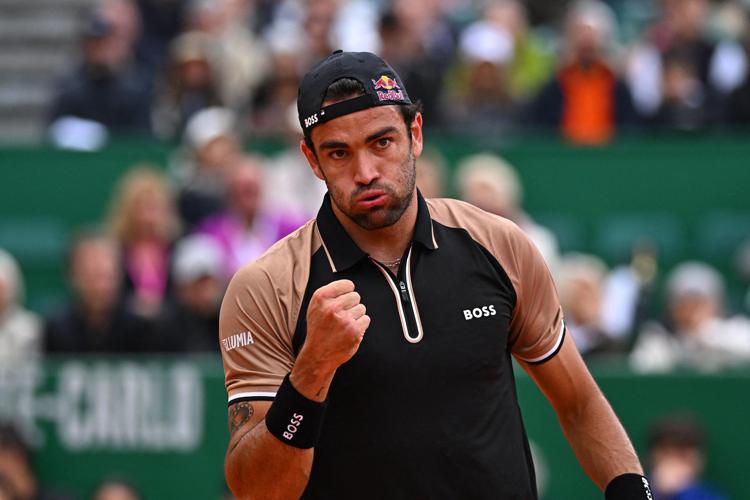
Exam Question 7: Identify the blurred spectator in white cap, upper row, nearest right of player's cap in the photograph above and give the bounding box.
[445,21,518,137]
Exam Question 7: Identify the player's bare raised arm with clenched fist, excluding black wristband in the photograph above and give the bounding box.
[225,280,370,500]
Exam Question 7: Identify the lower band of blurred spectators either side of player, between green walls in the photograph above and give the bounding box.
[0,141,750,372]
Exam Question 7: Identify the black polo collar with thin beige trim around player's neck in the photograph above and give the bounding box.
[316,190,438,272]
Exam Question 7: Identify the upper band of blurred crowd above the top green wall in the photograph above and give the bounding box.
[49,0,750,149]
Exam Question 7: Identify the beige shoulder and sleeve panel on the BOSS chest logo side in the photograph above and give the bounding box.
[427,199,564,362]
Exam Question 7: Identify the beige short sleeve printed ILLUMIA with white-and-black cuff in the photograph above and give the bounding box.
[219,261,294,403]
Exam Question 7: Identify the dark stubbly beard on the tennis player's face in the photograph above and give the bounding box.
[328,150,417,230]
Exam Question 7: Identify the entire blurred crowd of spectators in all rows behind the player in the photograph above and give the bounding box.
[0,0,750,500]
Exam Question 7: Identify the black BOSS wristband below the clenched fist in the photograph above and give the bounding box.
[266,375,327,449]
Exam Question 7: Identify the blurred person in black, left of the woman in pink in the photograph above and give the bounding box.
[44,232,148,353]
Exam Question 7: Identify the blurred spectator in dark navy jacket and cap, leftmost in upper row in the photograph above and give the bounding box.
[50,12,151,143]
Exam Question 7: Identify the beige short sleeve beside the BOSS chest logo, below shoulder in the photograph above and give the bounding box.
[506,226,565,363]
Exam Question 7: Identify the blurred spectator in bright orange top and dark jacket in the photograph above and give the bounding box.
[531,0,635,144]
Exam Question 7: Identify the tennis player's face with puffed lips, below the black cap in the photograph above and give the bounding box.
[301,106,422,229]
